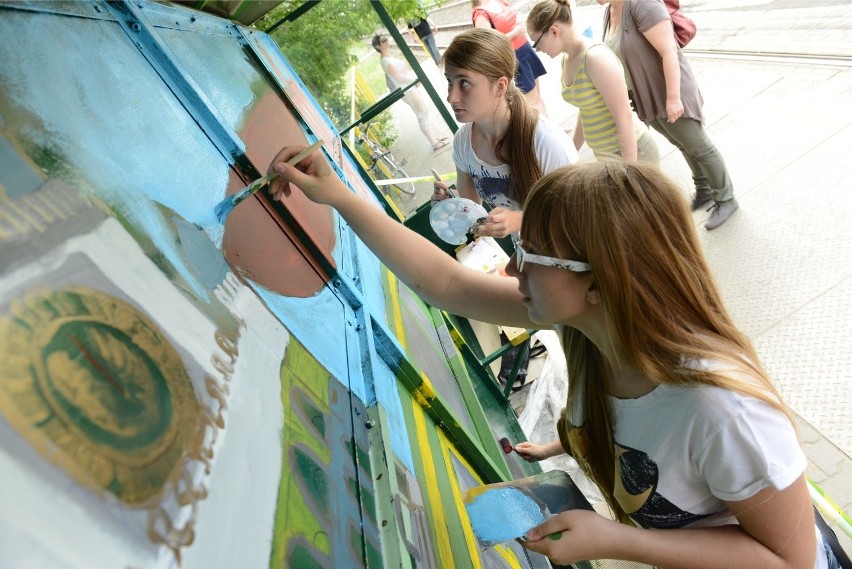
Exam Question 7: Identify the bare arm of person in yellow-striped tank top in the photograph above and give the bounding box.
[575,43,638,160]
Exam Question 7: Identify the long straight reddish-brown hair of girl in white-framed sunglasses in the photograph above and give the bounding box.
[521,160,792,520]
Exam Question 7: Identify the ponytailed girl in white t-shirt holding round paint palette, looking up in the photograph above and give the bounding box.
[432,28,578,237]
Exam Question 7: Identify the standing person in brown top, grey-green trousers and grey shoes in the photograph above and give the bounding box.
[598,0,739,229]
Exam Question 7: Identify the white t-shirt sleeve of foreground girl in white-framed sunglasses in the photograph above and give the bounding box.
[696,397,807,501]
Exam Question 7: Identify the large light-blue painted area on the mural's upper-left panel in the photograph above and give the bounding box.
[0,11,229,298]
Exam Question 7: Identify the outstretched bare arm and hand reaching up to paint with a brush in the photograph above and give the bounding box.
[268,146,536,328]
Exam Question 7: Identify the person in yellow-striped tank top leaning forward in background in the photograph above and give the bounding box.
[527,0,660,164]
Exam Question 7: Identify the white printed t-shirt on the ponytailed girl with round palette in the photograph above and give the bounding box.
[453,117,579,211]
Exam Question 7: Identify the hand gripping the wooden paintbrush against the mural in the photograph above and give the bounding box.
[266,145,342,204]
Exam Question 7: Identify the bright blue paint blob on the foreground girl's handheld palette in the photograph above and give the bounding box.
[465,487,545,545]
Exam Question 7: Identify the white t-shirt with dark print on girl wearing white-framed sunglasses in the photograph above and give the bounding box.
[569,364,827,569]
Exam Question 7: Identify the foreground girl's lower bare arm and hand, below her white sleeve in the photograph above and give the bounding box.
[523,476,816,569]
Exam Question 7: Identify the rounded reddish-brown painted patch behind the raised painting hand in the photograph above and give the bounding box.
[222,91,335,297]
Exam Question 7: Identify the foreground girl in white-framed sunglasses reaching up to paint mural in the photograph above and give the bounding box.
[269,147,827,569]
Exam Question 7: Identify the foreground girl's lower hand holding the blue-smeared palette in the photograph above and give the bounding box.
[520,510,620,565]
